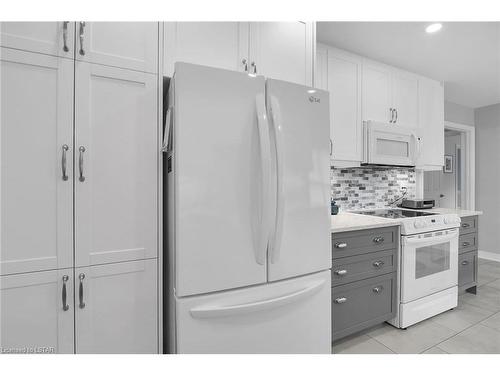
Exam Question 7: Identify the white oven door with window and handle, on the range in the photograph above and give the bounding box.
[401,228,458,303]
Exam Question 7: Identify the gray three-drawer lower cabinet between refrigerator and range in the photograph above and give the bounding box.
[332,227,399,340]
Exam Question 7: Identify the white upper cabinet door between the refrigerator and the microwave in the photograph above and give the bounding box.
[327,49,363,165]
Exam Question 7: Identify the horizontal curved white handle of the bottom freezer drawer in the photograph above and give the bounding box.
[190,280,326,319]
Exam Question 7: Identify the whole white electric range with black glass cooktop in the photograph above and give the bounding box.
[356,208,460,328]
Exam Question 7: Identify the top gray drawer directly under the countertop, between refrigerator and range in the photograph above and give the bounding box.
[332,227,398,259]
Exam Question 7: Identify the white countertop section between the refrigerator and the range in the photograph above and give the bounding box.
[330,212,400,233]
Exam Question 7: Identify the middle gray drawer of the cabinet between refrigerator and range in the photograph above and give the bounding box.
[332,250,396,286]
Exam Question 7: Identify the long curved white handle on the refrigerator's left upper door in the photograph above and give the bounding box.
[255,94,271,265]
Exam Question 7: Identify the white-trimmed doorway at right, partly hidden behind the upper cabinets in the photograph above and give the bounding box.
[424,122,475,210]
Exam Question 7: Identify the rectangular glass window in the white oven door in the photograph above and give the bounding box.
[415,242,450,279]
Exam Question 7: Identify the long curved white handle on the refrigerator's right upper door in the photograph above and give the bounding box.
[270,96,285,263]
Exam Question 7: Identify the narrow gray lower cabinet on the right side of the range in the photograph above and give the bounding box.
[458,216,479,294]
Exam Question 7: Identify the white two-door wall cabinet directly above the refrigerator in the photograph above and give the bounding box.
[163,22,314,85]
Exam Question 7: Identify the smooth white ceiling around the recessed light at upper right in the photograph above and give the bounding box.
[317,22,500,108]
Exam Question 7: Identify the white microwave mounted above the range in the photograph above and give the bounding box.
[363,121,420,167]
